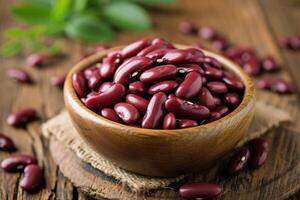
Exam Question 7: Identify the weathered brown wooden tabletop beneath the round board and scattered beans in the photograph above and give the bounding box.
[0,0,300,199]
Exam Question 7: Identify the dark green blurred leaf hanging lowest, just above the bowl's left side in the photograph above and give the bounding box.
[65,16,113,42]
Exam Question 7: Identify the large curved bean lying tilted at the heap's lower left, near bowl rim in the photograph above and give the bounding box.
[84,83,125,111]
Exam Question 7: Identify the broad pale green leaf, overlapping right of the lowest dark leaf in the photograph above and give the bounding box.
[103,1,151,31]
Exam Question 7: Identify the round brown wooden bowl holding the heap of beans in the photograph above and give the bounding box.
[64,45,255,176]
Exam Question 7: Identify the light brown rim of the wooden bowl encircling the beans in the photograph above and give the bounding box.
[64,44,255,136]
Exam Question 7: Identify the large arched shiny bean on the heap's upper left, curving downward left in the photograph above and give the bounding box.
[114,57,153,84]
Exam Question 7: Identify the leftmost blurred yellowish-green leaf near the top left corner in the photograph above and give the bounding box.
[11,3,50,24]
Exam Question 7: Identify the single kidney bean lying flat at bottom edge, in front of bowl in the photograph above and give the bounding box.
[179,183,223,199]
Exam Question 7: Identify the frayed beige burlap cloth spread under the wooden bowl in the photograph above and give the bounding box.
[42,102,291,192]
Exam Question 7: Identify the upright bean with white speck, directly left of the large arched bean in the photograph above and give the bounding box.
[100,52,122,78]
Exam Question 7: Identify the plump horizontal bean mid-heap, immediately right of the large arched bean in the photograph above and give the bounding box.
[140,65,177,84]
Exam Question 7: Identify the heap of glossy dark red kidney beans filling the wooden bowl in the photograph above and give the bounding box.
[72,38,244,129]
